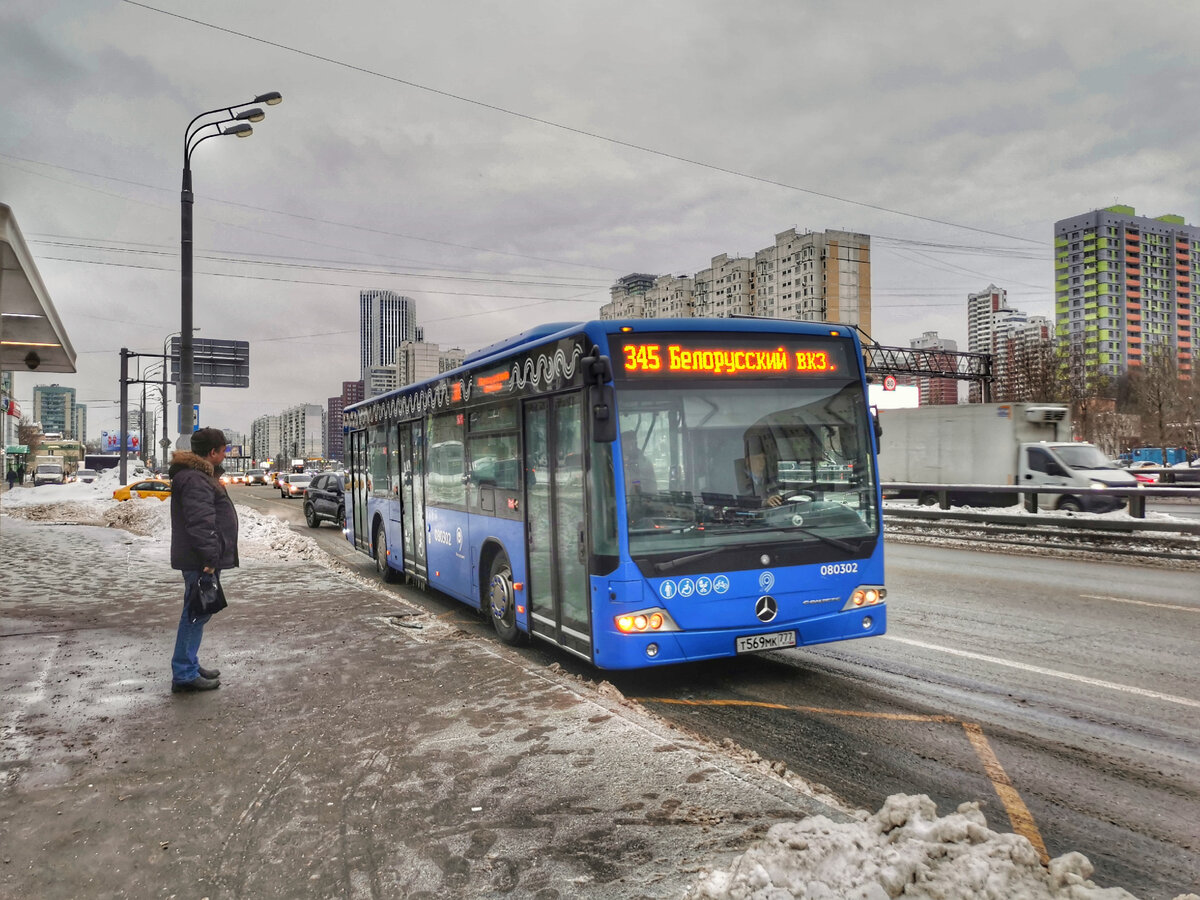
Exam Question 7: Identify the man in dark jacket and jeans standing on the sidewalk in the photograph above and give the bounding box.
[169,428,238,694]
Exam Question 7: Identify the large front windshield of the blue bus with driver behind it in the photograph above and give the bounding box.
[619,379,878,570]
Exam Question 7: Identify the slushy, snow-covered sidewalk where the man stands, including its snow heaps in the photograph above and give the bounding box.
[0,486,1195,900]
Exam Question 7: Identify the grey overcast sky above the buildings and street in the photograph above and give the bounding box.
[0,0,1200,437]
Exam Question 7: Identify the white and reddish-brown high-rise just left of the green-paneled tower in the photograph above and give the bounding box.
[967,284,1051,403]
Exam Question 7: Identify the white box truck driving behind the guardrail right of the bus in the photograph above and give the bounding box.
[878,403,1138,512]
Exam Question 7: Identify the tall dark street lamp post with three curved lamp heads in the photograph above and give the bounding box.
[175,91,283,450]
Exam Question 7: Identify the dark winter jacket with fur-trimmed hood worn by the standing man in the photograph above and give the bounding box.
[168,450,238,570]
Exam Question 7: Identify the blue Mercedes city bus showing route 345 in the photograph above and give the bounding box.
[344,318,887,668]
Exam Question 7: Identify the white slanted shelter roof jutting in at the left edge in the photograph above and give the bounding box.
[0,203,76,372]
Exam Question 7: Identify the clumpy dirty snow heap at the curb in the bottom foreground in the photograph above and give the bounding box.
[686,794,1200,900]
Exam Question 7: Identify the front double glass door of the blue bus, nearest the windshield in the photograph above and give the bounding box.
[524,392,592,660]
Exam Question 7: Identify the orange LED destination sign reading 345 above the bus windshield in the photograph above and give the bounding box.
[612,335,852,378]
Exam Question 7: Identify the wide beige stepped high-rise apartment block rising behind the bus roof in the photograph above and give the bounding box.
[600,228,871,334]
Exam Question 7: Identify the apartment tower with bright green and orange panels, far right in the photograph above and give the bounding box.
[1054,206,1200,379]
